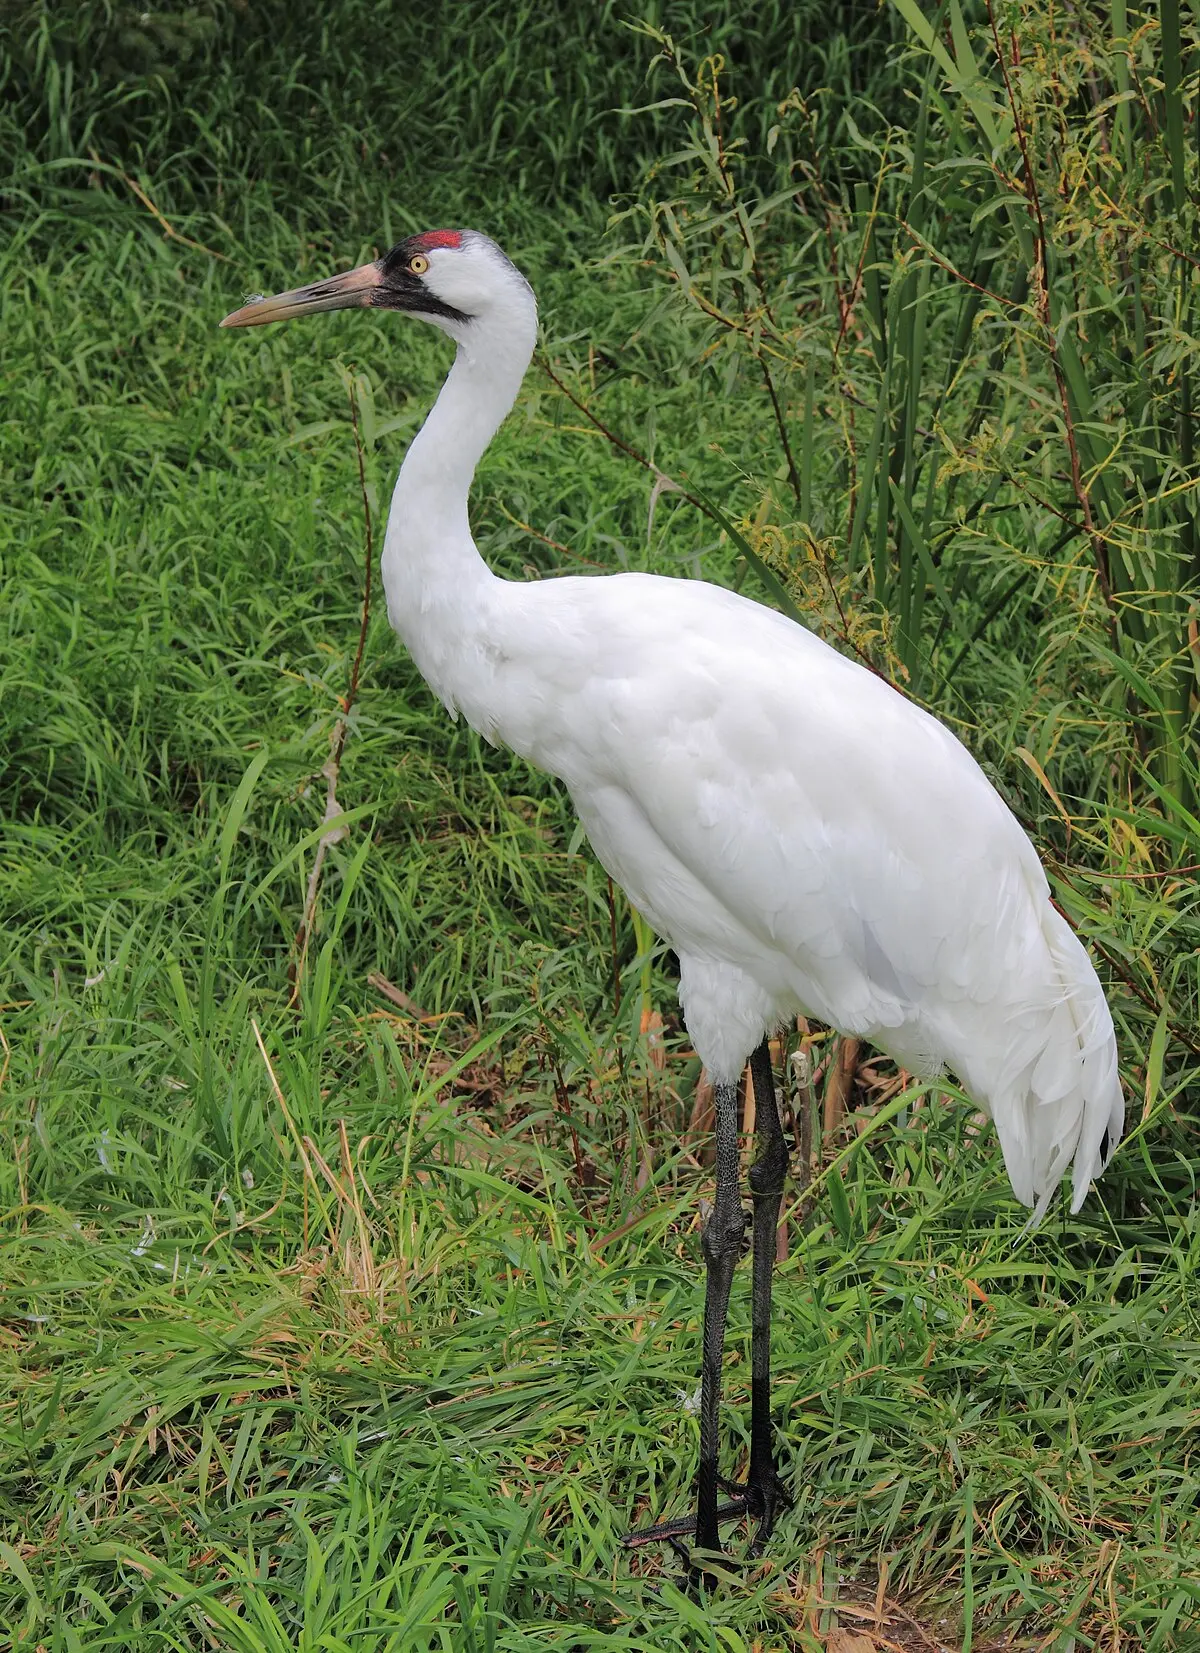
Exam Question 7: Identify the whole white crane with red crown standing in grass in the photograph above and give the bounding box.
[221,230,1124,1552]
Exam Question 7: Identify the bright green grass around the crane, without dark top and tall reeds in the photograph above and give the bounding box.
[0,8,1200,1653]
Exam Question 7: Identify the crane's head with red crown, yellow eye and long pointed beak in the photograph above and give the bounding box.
[221,230,537,344]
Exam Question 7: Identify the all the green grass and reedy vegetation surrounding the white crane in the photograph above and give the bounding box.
[0,0,1200,1653]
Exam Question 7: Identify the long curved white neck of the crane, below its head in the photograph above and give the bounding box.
[382,317,536,721]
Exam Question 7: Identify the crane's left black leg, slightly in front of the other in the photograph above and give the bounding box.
[696,1084,745,1551]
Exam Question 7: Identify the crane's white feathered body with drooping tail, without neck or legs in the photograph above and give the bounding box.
[489,575,1124,1215]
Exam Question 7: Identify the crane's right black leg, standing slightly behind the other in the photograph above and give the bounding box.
[745,1040,790,1551]
